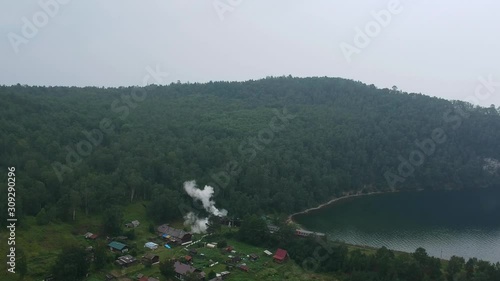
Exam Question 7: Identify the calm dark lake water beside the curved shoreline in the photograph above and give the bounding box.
[295,189,500,262]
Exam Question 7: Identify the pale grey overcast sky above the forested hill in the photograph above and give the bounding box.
[0,0,500,106]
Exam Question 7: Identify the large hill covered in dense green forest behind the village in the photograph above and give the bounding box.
[0,77,500,222]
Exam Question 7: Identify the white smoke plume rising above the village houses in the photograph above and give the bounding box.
[184,180,227,233]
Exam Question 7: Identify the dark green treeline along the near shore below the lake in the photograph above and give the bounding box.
[233,216,500,281]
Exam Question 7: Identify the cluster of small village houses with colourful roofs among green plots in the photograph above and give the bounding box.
[82,215,325,281]
